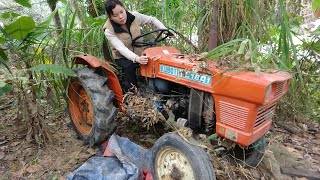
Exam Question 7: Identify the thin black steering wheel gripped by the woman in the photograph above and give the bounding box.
[132,29,173,47]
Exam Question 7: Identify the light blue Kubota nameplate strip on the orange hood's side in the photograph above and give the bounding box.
[160,64,212,85]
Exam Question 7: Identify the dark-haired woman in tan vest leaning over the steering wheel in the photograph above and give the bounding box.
[103,0,171,91]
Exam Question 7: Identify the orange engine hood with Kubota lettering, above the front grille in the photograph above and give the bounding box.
[140,46,291,105]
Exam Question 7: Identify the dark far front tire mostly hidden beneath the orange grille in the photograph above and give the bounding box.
[226,136,266,168]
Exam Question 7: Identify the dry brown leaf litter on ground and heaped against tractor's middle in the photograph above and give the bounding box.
[0,85,320,179]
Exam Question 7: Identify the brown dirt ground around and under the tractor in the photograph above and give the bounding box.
[0,90,320,180]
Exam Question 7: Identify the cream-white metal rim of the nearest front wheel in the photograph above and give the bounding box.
[156,147,195,180]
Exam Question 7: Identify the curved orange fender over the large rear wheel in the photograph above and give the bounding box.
[73,55,125,112]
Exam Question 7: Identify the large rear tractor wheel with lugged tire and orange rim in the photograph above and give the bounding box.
[68,68,118,146]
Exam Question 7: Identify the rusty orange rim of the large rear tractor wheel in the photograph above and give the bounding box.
[68,82,93,135]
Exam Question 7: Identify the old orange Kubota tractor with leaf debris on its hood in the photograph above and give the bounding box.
[68,30,291,179]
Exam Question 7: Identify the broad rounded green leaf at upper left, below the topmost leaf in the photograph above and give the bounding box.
[4,16,35,40]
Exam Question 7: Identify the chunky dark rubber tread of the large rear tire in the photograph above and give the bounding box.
[71,68,118,146]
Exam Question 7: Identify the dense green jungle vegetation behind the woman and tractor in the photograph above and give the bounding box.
[0,0,320,146]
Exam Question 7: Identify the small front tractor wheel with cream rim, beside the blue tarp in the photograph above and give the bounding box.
[151,133,216,180]
